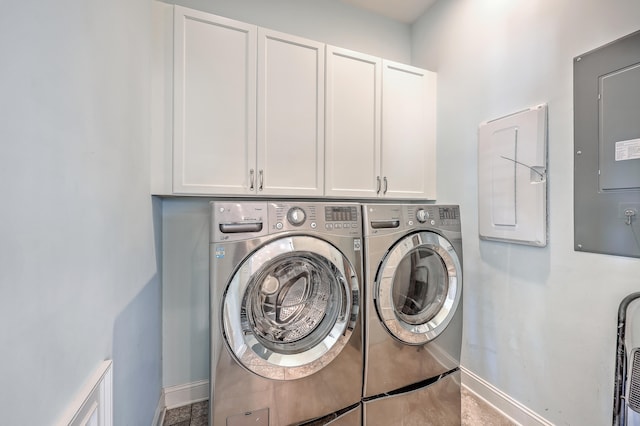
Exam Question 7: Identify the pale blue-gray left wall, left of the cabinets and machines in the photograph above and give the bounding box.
[0,0,161,426]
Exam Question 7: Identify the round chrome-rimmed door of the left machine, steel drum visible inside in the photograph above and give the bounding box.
[222,236,360,380]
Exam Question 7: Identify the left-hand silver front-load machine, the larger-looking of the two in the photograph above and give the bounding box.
[209,201,363,426]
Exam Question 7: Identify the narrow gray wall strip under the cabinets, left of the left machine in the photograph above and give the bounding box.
[162,198,210,387]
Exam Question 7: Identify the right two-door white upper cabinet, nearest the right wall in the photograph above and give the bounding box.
[325,46,436,199]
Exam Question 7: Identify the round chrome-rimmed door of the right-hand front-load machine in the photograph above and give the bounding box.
[374,232,462,345]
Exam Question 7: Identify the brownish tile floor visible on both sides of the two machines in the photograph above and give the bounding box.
[163,388,517,426]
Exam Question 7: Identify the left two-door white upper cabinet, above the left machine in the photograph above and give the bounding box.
[162,6,324,196]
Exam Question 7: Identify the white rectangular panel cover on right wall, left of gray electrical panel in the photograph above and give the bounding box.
[478,104,547,247]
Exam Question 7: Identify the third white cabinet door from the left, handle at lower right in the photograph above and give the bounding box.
[325,46,382,197]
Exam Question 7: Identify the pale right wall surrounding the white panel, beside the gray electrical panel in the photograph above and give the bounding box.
[412,0,640,425]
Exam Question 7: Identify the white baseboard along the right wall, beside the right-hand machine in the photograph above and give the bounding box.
[460,367,553,426]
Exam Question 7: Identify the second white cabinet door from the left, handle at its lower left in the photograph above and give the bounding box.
[258,28,324,195]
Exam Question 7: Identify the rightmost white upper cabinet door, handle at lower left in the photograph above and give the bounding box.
[382,61,436,199]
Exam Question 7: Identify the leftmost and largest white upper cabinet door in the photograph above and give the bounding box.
[173,6,257,194]
